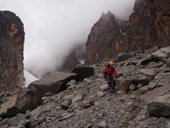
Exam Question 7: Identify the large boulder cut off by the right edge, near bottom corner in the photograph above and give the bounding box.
[147,94,170,117]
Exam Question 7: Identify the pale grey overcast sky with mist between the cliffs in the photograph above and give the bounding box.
[0,0,135,75]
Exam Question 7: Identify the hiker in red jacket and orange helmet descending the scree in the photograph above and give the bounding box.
[104,61,118,92]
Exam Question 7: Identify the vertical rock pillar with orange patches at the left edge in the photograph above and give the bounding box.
[0,11,25,91]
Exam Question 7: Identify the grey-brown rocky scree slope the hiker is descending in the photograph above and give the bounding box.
[0,47,170,128]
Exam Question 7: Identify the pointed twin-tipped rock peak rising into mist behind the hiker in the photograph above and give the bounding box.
[86,11,125,64]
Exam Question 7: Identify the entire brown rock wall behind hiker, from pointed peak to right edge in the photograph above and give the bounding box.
[86,0,170,64]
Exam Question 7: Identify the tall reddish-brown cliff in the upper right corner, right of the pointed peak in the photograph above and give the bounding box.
[127,0,170,50]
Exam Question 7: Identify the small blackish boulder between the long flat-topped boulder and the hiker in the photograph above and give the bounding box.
[72,65,94,81]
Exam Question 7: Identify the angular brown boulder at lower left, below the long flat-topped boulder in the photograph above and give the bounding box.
[0,89,41,117]
